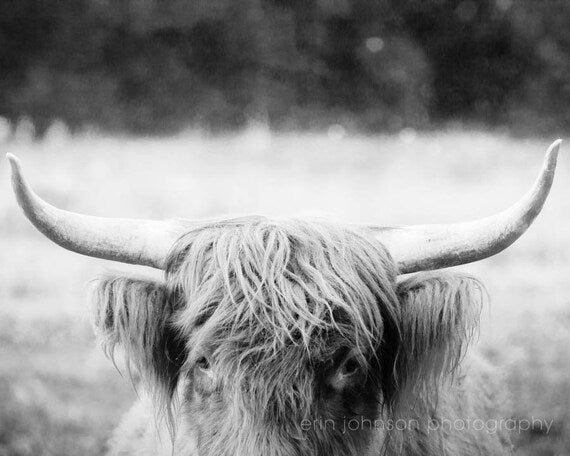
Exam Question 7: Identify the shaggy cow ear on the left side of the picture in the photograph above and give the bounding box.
[93,276,184,396]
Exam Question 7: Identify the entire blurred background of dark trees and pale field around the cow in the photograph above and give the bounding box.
[0,0,570,456]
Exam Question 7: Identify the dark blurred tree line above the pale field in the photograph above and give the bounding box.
[0,0,570,136]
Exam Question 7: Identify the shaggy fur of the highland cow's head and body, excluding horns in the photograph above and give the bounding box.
[95,217,508,456]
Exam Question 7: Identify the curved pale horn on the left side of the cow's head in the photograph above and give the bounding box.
[6,154,188,269]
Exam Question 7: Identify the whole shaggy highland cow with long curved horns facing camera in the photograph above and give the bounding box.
[5,141,559,456]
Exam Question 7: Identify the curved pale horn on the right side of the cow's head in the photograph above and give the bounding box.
[370,139,562,274]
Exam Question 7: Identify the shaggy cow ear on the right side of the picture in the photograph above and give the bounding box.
[394,272,487,400]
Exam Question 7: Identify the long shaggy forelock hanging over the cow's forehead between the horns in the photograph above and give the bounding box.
[162,218,397,378]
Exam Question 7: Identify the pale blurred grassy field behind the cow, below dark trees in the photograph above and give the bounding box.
[0,130,570,456]
